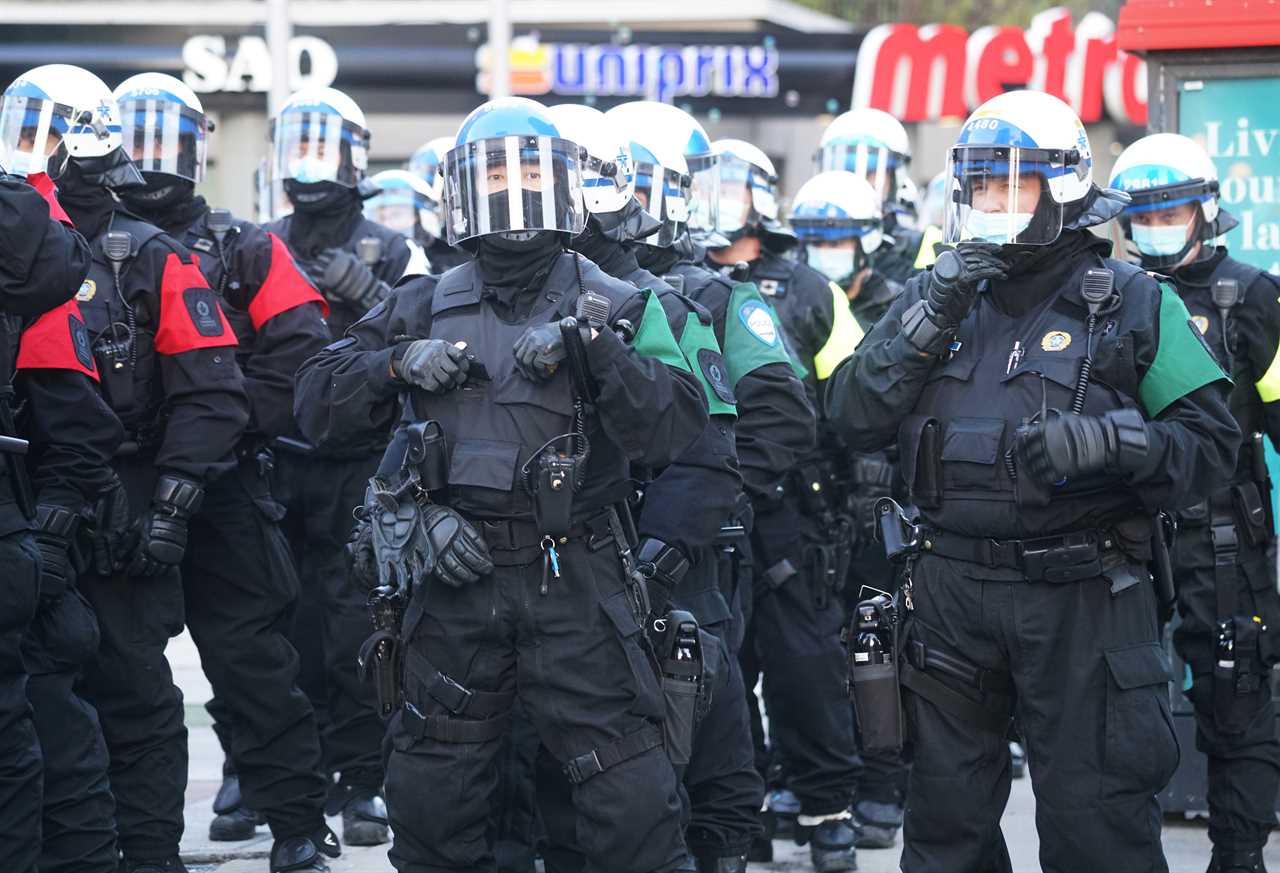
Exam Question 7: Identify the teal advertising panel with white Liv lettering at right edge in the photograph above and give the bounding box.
[1178,77,1280,275]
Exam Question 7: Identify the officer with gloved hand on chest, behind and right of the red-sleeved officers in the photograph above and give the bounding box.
[266,88,412,846]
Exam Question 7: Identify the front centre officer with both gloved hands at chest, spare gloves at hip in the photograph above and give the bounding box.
[297,99,707,873]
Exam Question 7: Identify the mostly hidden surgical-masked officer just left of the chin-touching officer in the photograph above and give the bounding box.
[788,170,906,849]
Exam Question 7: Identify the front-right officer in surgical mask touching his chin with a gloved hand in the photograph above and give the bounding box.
[828,91,1239,873]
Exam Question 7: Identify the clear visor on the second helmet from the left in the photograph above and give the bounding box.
[120,100,209,183]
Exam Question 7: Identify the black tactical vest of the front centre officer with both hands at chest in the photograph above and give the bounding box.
[412,252,641,521]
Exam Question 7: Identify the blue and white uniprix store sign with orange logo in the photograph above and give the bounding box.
[476,36,778,102]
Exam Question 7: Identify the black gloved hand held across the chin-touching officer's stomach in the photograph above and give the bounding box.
[1015,410,1149,485]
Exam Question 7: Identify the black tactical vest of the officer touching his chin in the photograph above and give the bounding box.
[899,257,1151,539]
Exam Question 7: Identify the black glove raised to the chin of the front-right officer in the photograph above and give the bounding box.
[902,242,1009,353]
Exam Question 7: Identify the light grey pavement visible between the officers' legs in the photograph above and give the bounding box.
[168,635,1280,873]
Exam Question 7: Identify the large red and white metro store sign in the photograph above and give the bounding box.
[852,8,1147,125]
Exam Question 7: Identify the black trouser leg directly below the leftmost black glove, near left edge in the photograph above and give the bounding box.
[22,588,116,873]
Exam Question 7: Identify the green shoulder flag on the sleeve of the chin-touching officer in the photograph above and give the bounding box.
[1138,282,1230,419]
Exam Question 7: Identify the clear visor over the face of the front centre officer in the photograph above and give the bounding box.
[444,136,586,246]
